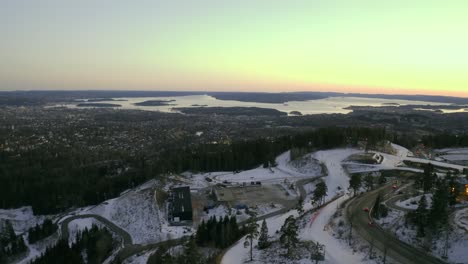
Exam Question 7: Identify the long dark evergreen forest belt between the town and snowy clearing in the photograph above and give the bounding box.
[0,127,406,214]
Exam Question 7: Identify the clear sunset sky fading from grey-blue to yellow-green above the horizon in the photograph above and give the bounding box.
[0,0,468,97]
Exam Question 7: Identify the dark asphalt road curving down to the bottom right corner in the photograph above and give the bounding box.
[346,184,446,264]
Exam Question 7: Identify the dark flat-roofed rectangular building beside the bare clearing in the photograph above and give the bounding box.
[169,186,193,223]
